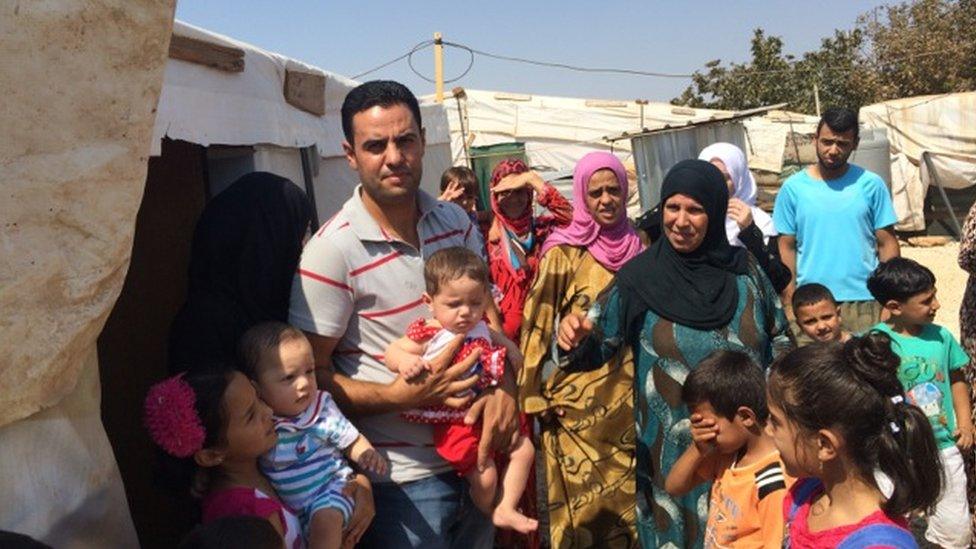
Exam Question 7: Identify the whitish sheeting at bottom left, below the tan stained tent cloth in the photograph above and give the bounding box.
[0,348,138,549]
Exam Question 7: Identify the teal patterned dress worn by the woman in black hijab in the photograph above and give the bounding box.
[567,268,794,548]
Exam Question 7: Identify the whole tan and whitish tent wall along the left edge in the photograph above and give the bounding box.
[0,0,174,547]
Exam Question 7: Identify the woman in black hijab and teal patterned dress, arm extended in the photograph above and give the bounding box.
[558,160,793,548]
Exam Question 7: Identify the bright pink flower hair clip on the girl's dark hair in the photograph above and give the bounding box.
[143,374,207,458]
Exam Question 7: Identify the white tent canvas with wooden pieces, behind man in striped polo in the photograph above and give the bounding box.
[152,20,451,221]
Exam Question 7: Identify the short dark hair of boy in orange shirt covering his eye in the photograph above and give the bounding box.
[681,349,769,424]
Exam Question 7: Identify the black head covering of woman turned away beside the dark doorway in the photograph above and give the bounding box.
[169,172,314,371]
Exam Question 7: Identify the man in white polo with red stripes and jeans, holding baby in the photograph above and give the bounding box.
[290,81,518,549]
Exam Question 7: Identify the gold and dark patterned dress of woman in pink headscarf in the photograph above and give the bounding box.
[519,245,637,549]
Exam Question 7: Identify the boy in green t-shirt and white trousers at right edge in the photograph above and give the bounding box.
[868,257,974,547]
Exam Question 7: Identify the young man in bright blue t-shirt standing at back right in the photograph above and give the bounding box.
[773,108,901,333]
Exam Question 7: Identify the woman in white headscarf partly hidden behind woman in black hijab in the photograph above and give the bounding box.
[698,143,792,293]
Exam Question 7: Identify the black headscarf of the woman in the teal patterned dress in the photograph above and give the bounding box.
[617,160,748,330]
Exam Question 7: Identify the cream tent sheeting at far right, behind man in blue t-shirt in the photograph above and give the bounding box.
[860,92,976,231]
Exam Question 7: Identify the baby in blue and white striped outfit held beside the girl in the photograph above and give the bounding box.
[240,322,387,549]
